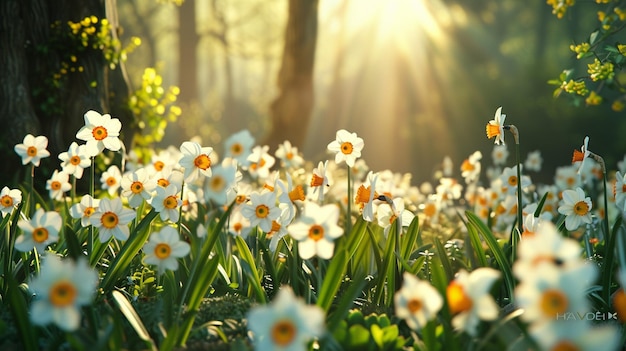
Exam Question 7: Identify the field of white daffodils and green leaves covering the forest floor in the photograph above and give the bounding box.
[0,108,626,350]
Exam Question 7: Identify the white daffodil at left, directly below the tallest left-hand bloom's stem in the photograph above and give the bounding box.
[89,198,137,243]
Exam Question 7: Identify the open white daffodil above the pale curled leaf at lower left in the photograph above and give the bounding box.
[142,226,190,274]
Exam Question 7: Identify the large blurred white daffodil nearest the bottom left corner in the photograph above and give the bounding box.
[28,253,98,331]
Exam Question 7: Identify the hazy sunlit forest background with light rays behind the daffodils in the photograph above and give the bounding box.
[3,0,626,186]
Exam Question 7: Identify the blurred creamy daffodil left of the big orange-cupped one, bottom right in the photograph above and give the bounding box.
[394,272,443,330]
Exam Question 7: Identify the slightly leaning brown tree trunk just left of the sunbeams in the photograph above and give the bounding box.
[266,0,318,147]
